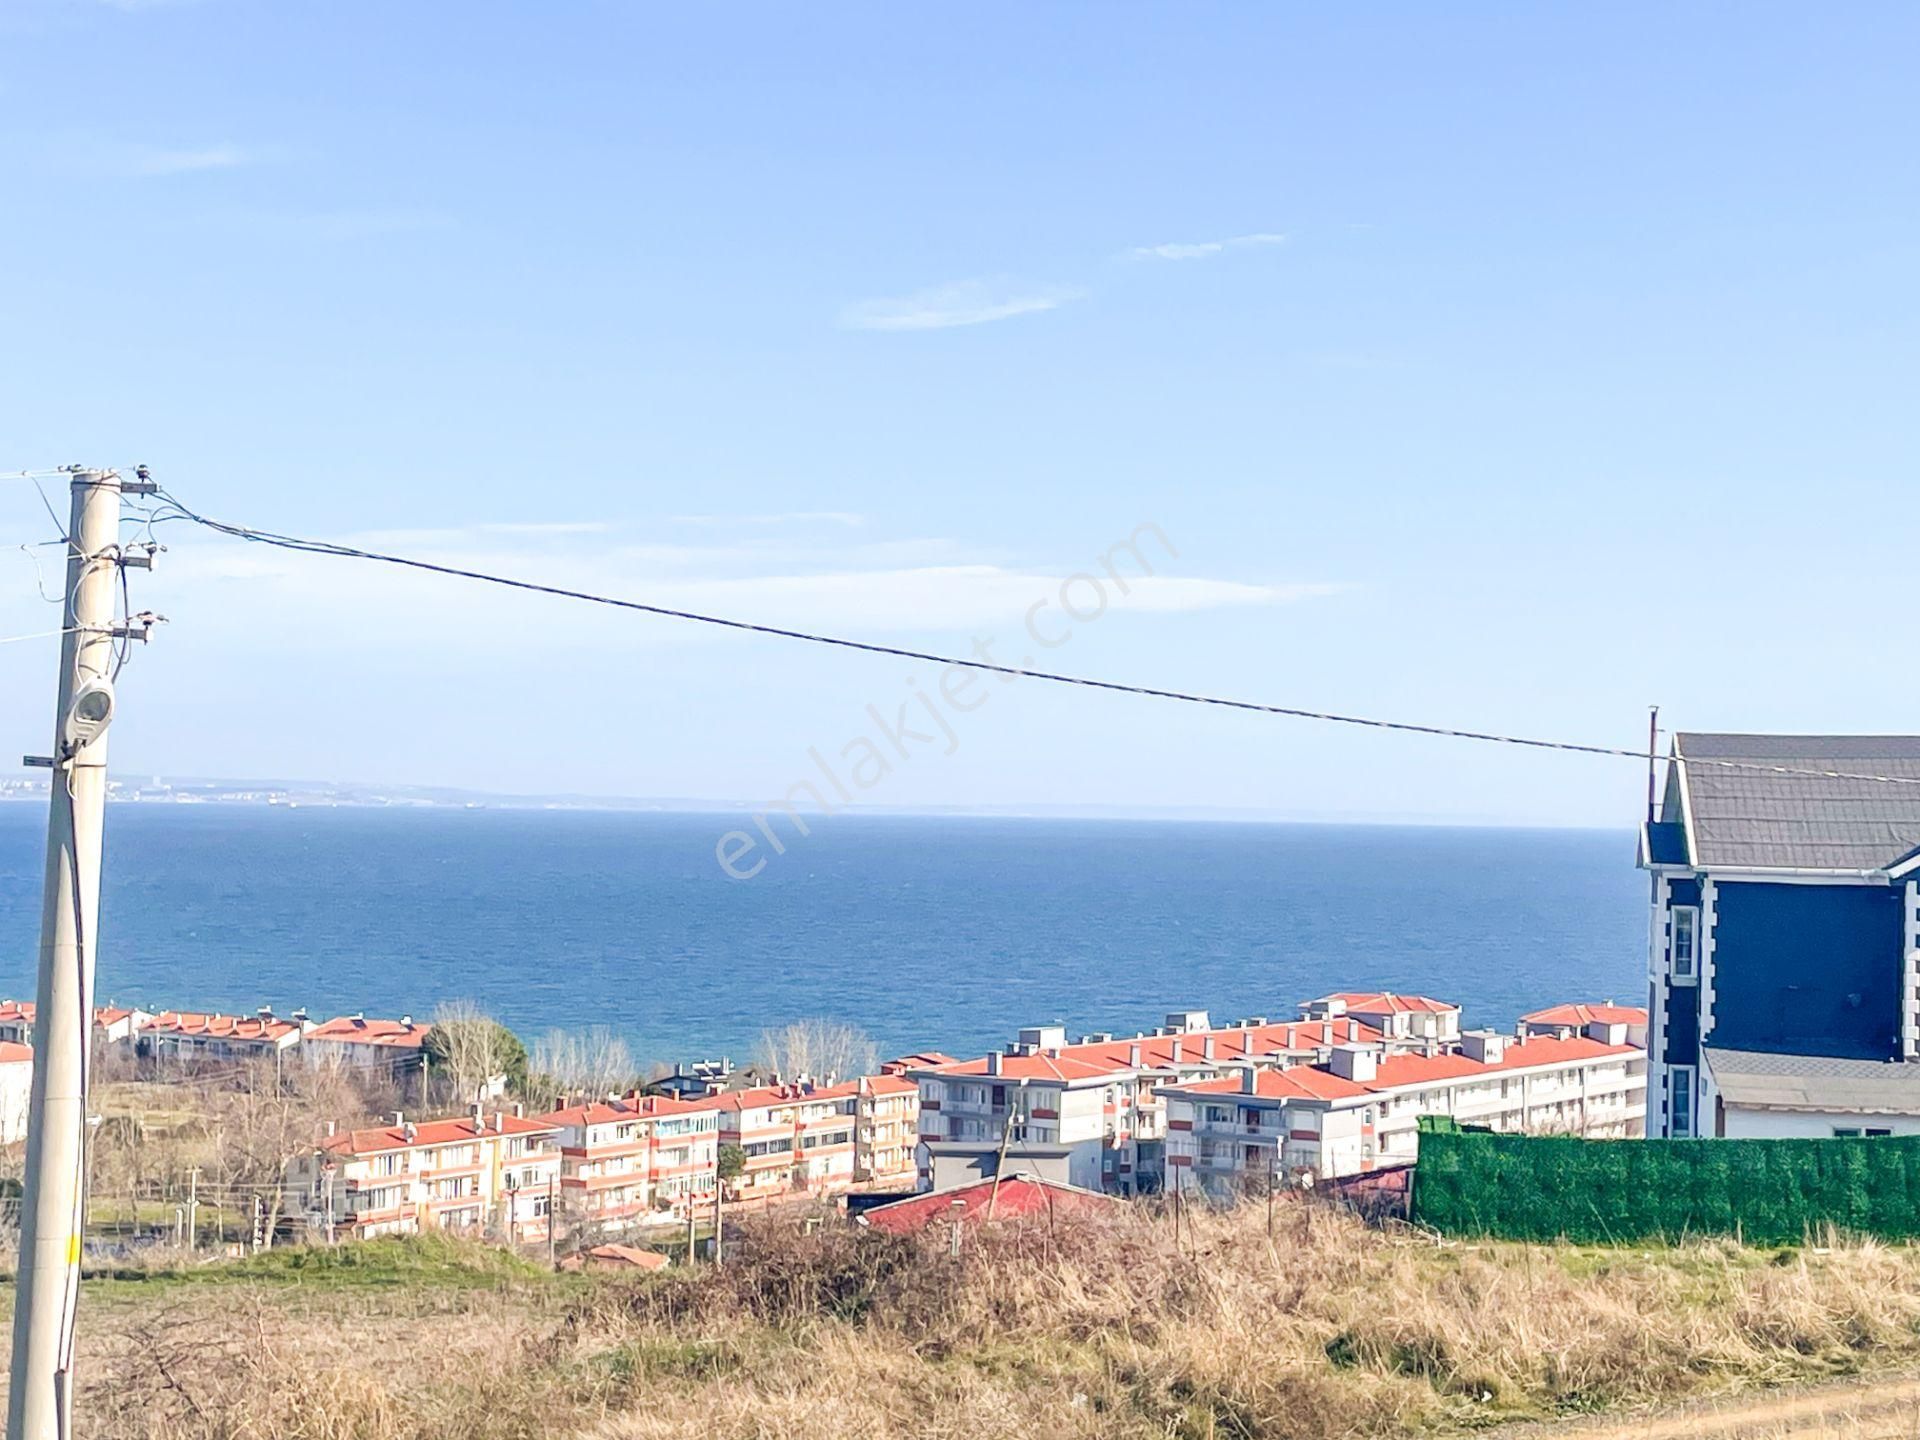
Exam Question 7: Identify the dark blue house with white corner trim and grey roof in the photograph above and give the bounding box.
[1640,733,1920,1137]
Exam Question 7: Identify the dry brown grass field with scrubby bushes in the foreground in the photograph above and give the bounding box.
[41,1208,1920,1440]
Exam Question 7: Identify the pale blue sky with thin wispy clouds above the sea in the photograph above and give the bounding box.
[0,0,1920,824]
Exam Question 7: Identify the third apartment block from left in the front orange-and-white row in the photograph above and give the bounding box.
[714,1081,860,1202]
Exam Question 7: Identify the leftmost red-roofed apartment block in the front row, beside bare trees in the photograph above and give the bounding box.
[284,1110,561,1244]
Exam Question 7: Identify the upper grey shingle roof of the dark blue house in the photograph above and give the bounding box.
[1663,733,1920,870]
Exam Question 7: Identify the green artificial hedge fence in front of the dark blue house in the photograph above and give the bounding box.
[1411,1117,1920,1244]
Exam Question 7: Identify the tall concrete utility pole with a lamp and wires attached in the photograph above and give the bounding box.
[6,470,129,1440]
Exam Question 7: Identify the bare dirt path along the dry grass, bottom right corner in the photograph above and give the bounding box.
[1498,1375,1920,1440]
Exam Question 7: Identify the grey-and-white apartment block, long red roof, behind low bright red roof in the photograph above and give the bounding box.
[914,1010,1380,1194]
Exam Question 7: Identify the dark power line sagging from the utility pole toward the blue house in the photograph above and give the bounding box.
[135,488,1920,785]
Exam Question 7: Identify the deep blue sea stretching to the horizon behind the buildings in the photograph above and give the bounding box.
[0,803,1645,1060]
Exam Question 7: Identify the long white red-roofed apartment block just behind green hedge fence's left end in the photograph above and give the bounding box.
[1165,1025,1647,1194]
